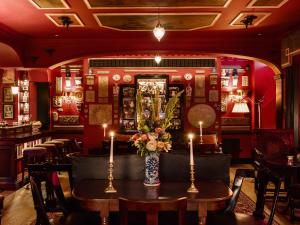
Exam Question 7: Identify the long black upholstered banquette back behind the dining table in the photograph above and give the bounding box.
[70,152,231,184]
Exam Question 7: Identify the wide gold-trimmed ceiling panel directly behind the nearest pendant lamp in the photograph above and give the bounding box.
[94,13,220,31]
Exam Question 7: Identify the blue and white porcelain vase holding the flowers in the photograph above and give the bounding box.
[144,152,160,186]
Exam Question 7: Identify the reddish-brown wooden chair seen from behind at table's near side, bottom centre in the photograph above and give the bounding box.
[119,198,187,225]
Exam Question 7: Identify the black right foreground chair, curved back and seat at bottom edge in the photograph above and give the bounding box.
[207,169,280,225]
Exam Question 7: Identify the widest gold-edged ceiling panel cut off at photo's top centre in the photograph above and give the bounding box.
[84,0,231,9]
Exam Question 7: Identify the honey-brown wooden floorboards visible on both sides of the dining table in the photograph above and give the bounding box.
[1,164,300,225]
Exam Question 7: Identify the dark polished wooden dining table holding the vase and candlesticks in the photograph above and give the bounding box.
[72,179,232,225]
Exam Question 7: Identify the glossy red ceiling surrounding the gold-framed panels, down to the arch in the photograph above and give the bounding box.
[0,0,300,67]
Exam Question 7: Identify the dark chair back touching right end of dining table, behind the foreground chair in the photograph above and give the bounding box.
[224,169,255,212]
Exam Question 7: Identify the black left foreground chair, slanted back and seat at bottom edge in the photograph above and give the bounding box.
[30,177,100,225]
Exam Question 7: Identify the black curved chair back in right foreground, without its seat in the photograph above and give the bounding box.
[253,168,281,225]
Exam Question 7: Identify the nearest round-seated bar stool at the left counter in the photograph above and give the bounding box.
[22,147,48,184]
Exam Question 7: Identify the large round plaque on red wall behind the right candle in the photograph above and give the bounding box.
[188,104,216,128]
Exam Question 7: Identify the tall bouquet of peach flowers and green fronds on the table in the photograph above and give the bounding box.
[131,89,183,156]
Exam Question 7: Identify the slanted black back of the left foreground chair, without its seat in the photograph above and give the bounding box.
[30,177,51,225]
